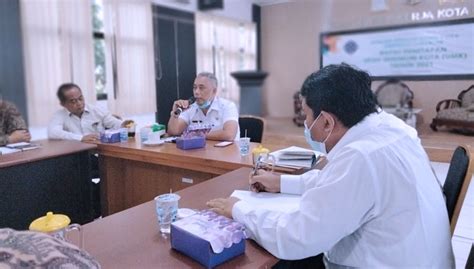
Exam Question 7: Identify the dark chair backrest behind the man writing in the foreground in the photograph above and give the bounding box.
[443,145,474,234]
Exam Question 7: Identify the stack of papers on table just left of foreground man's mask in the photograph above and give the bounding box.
[270,146,322,168]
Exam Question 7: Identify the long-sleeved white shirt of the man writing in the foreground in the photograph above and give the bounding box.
[232,112,454,268]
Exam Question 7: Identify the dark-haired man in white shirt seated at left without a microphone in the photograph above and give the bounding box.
[48,83,130,142]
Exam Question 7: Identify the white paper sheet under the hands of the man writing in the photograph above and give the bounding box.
[231,190,301,213]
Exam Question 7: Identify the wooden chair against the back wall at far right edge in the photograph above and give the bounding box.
[430,85,474,134]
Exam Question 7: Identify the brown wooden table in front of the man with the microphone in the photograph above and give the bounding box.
[98,140,295,216]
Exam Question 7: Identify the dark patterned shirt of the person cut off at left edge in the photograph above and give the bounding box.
[0,100,27,146]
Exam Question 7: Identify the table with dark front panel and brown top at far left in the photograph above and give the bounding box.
[0,140,96,229]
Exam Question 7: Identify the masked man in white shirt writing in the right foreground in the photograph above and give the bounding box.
[208,64,454,268]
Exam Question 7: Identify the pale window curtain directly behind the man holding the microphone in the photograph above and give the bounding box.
[196,13,256,104]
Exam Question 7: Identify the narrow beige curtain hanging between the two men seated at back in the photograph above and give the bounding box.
[104,0,156,116]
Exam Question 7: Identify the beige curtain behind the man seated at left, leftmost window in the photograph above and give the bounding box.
[20,0,95,126]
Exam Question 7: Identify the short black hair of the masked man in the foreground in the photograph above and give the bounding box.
[301,63,377,128]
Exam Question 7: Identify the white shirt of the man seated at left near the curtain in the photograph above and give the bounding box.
[48,105,122,141]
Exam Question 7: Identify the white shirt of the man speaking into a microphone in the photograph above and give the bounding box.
[179,97,240,140]
